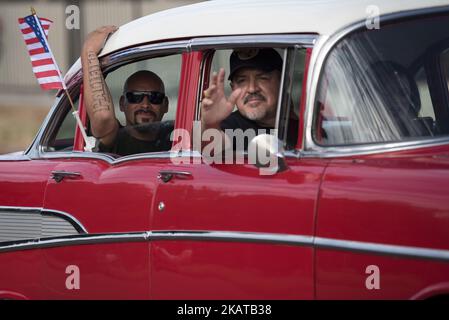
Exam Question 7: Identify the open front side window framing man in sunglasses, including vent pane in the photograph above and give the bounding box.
[42,54,181,157]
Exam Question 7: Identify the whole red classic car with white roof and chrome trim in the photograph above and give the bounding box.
[0,0,449,299]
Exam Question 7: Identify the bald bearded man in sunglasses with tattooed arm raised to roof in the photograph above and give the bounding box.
[81,26,173,156]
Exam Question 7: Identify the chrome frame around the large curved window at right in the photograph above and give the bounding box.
[301,6,449,158]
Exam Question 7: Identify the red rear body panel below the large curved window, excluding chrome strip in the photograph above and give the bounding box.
[316,146,449,299]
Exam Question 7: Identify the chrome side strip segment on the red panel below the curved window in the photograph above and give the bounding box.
[314,237,449,262]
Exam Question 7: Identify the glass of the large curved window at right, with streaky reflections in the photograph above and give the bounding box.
[313,17,449,146]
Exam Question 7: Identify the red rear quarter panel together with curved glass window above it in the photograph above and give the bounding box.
[310,12,449,299]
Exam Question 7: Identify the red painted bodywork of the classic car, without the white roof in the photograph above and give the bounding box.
[0,1,449,299]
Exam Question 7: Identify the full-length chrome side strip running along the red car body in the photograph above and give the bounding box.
[0,230,449,262]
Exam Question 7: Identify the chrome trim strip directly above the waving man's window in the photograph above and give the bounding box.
[190,34,318,50]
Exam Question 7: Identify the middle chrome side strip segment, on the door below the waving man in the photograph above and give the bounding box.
[148,231,313,246]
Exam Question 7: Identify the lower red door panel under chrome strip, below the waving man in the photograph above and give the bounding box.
[151,241,313,300]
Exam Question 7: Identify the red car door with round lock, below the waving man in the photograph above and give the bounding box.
[151,37,326,299]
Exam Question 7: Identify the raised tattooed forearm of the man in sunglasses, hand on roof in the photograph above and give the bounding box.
[81,26,119,146]
